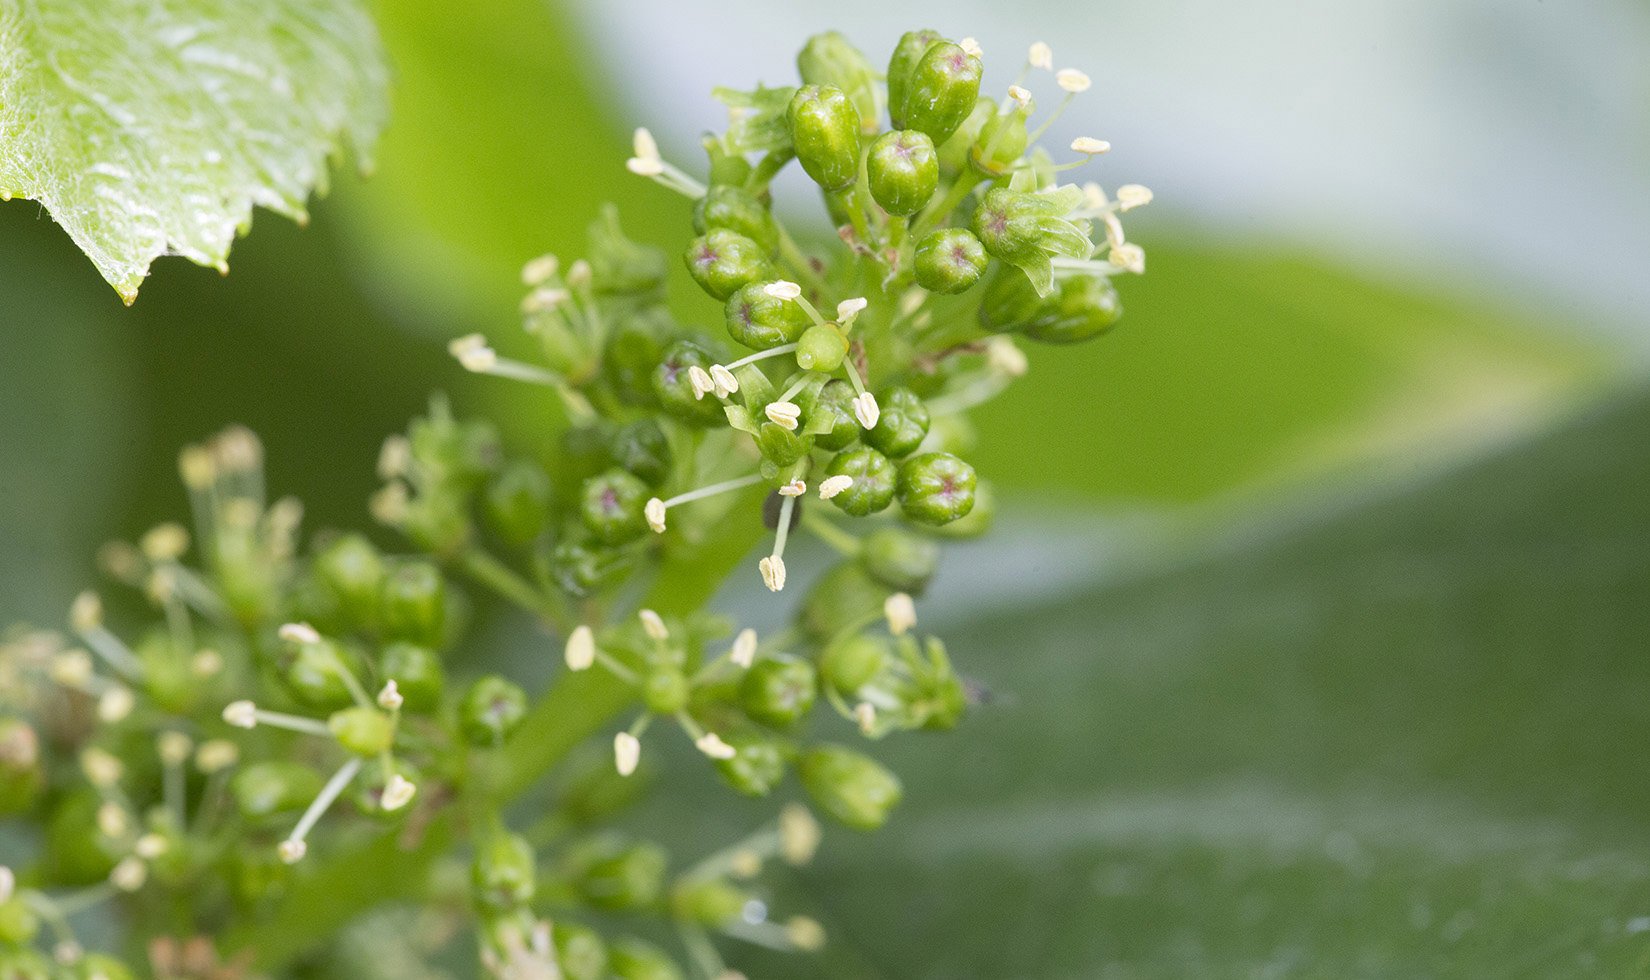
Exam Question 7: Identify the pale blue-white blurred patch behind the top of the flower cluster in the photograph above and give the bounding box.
[576,0,1650,346]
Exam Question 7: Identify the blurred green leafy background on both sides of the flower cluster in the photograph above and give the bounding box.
[0,0,1650,977]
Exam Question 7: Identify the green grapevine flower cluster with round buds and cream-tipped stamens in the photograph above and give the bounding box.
[0,22,1150,980]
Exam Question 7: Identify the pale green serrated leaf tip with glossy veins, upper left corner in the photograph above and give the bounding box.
[0,0,388,304]
